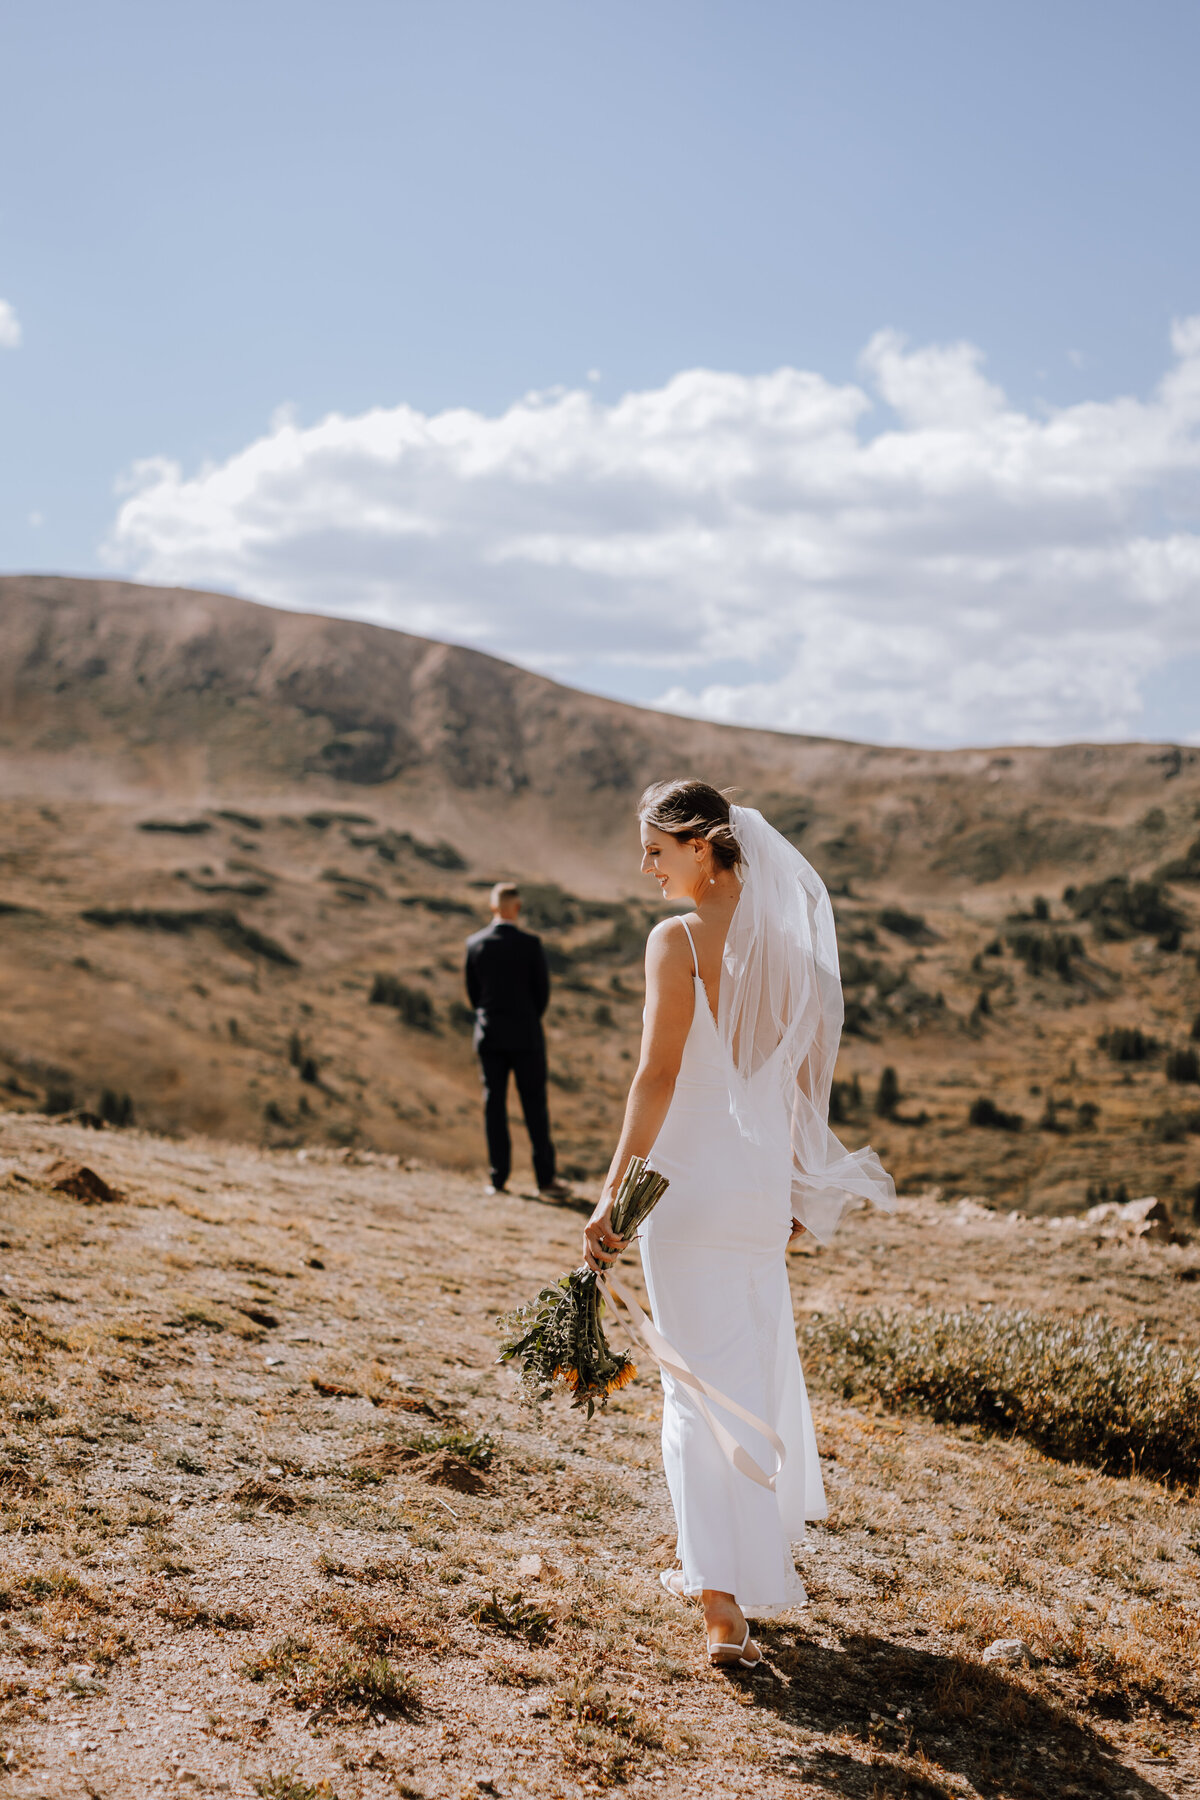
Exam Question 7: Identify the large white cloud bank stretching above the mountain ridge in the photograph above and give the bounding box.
[104,317,1200,743]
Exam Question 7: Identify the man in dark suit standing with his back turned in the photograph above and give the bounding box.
[466,882,569,1201]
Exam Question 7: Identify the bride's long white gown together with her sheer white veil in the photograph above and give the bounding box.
[639,806,894,1618]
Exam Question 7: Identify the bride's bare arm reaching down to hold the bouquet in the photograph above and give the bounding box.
[583,918,696,1269]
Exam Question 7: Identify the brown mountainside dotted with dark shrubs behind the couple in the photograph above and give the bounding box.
[0,578,1200,1226]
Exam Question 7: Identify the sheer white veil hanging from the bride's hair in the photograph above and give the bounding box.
[718,806,896,1244]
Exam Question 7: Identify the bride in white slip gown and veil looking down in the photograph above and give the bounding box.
[585,781,896,1669]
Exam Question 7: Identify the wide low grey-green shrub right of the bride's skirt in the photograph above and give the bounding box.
[806,1309,1200,1485]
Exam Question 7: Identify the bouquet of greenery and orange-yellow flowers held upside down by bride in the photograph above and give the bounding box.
[500,1156,667,1418]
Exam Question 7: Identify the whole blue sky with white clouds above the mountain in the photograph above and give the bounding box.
[0,0,1200,745]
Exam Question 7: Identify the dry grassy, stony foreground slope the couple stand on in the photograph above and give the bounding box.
[0,1112,1200,1800]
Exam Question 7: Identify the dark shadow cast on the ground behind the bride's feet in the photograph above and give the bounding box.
[736,1624,1166,1800]
